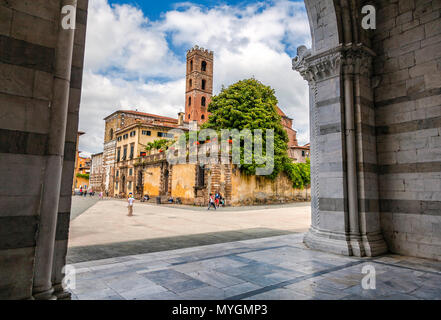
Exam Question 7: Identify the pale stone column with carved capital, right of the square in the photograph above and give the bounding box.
[293,46,386,256]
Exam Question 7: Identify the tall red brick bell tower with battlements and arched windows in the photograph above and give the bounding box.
[185,46,213,125]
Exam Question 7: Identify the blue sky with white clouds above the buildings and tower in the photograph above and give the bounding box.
[80,0,311,153]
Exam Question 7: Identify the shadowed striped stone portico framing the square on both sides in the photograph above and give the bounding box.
[0,0,441,299]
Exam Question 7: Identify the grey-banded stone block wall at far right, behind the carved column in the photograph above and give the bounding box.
[373,0,441,260]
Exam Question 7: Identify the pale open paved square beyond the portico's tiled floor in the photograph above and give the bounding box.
[67,197,311,263]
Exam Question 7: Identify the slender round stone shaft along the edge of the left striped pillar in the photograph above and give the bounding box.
[32,0,77,300]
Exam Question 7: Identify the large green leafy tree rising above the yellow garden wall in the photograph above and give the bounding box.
[202,79,309,188]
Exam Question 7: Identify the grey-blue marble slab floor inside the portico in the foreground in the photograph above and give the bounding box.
[71,233,441,300]
